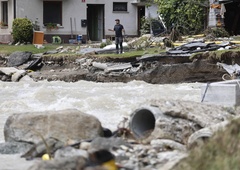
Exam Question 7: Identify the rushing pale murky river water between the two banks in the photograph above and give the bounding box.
[0,81,202,170]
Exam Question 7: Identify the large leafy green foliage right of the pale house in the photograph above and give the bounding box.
[154,0,209,34]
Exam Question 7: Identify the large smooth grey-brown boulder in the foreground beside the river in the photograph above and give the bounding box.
[4,109,103,143]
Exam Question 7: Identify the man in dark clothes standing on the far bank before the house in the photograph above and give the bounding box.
[108,19,125,54]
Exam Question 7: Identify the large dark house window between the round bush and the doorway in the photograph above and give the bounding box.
[43,1,62,26]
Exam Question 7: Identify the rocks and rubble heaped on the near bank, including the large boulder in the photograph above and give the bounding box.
[0,100,235,170]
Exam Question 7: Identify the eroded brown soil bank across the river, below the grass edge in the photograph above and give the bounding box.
[0,51,237,84]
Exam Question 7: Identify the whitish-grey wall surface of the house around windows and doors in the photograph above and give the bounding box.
[0,0,157,42]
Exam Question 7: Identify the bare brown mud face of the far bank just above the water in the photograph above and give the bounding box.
[29,53,226,84]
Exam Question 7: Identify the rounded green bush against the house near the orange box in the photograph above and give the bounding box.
[12,18,33,43]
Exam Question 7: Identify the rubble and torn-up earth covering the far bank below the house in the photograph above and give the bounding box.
[0,34,238,83]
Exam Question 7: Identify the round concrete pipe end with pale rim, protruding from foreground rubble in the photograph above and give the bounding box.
[129,106,162,139]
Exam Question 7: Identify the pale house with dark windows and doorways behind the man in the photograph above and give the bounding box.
[0,0,158,43]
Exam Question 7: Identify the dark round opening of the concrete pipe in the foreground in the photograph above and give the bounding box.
[130,109,156,138]
